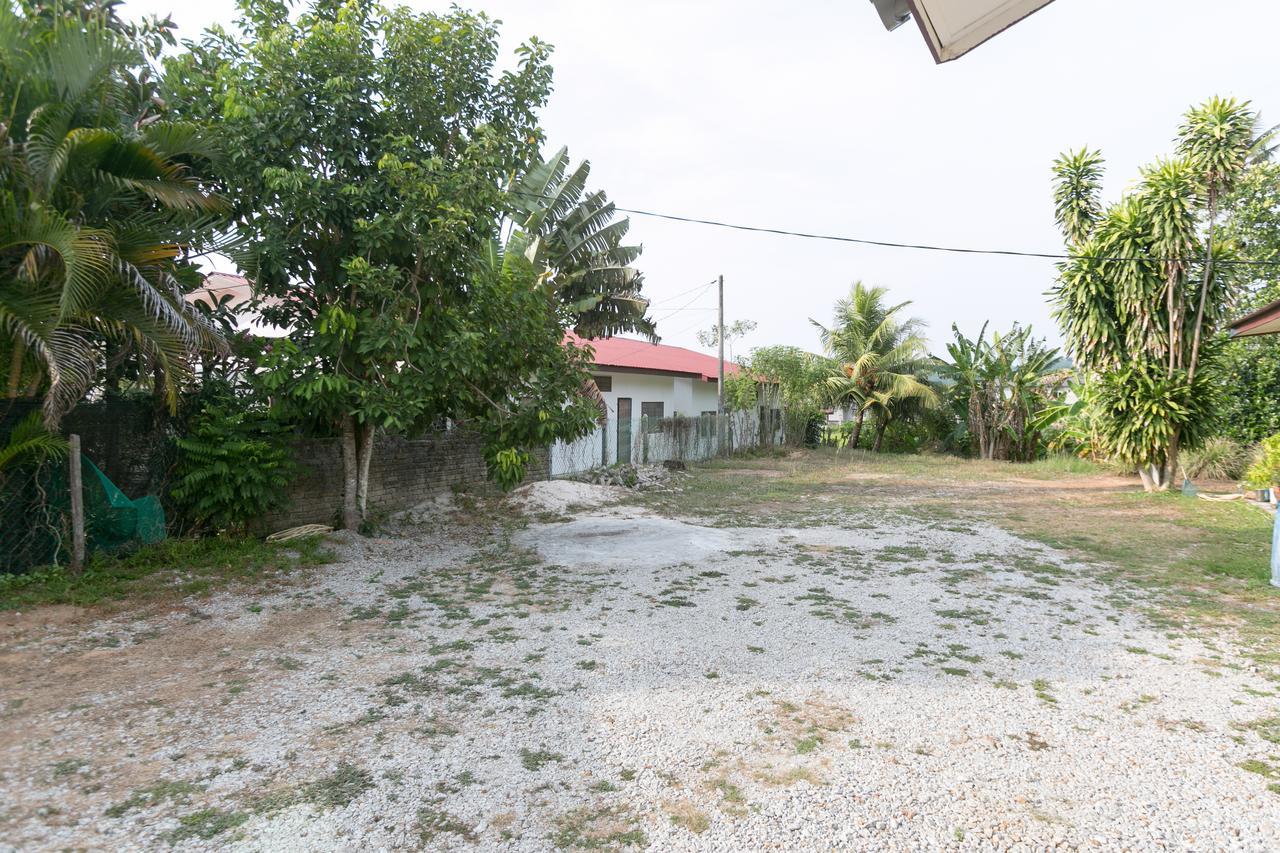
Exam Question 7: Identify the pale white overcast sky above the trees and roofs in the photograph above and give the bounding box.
[135,0,1280,352]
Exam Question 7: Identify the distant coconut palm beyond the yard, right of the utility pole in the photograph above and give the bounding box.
[809,282,937,452]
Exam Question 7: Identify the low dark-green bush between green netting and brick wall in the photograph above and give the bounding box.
[173,398,294,534]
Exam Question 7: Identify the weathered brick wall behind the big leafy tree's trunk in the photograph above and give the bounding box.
[261,429,549,532]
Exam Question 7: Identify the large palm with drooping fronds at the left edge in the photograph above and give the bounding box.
[0,4,223,425]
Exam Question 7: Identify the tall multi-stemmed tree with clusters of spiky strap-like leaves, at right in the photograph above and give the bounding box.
[1053,97,1256,491]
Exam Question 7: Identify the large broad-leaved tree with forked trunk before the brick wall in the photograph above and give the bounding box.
[166,0,604,528]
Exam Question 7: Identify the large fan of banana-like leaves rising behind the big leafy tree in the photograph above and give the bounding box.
[508,149,658,341]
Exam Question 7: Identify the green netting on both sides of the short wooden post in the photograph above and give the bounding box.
[0,455,165,573]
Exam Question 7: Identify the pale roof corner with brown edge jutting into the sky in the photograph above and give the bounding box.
[872,0,1052,63]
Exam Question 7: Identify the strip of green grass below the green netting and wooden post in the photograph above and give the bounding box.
[0,537,333,610]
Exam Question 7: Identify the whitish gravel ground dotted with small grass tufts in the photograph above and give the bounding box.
[0,485,1280,850]
